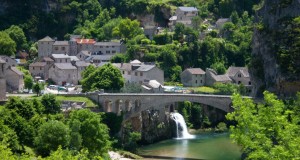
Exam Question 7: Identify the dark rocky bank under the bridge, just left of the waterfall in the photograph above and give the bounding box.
[129,109,174,143]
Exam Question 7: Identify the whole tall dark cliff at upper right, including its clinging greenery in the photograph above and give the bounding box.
[251,0,300,96]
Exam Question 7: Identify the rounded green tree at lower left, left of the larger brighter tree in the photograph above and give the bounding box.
[34,121,70,156]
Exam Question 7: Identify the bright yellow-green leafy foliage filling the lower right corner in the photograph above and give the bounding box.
[226,92,300,159]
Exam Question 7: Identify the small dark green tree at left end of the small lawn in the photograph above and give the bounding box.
[42,94,61,114]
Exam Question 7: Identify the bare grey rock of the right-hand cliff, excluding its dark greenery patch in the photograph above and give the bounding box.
[250,0,300,96]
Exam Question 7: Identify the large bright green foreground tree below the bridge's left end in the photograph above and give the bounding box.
[68,109,111,156]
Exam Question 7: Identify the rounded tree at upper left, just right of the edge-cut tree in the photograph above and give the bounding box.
[5,25,27,50]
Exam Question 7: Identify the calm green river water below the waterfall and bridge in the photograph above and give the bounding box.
[139,133,241,160]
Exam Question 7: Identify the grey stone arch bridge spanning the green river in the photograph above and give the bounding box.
[87,93,246,117]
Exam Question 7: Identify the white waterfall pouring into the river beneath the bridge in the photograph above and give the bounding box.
[171,113,195,139]
